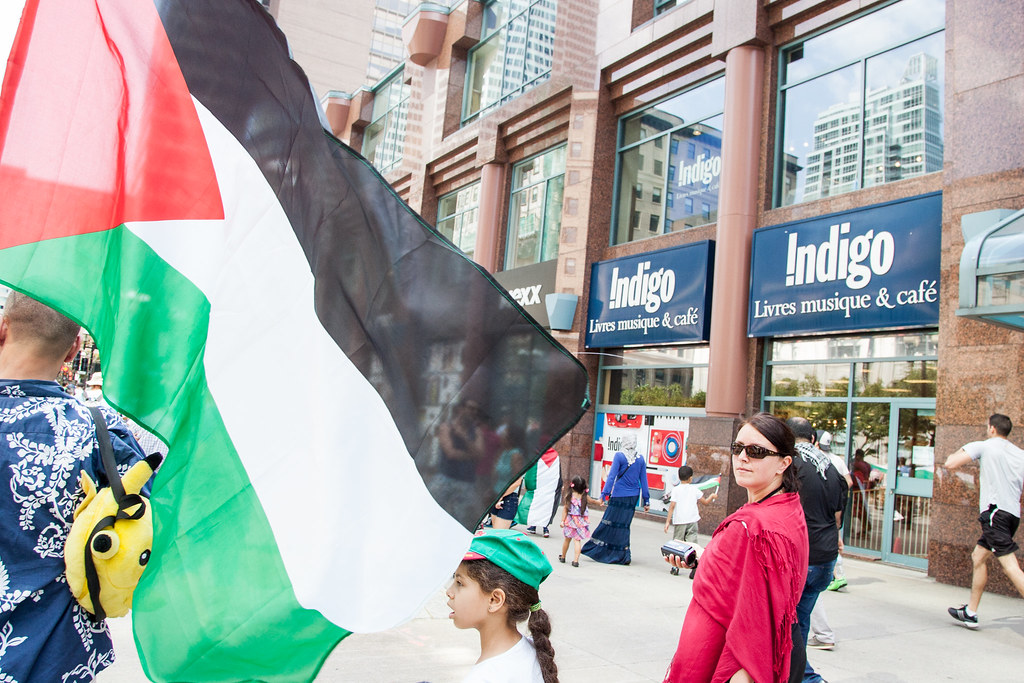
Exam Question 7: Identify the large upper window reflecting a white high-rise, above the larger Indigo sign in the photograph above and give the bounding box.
[775,0,945,206]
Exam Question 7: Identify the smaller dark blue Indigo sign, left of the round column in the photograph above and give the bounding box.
[586,240,715,348]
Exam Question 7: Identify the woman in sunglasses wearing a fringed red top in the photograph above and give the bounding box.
[665,413,808,683]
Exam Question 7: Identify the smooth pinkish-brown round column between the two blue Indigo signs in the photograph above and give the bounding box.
[706,45,765,418]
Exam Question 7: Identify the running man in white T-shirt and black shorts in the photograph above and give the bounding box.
[945,413,1024,629]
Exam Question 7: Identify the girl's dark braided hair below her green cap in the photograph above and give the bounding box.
[463,560,558,683]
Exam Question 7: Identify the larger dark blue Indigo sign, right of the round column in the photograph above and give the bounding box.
[748,193,942,337]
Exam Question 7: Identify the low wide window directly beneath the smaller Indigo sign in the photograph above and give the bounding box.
[600,346,709,408]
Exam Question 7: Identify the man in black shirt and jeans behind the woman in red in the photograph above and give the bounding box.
[786,418,849,683]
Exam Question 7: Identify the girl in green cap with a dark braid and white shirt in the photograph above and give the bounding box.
[446,529,558,683]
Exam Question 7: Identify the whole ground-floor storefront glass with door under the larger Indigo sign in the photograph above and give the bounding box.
[763,331,938,567]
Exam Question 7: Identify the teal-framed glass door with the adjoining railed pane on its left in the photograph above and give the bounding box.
[844,399,935,568]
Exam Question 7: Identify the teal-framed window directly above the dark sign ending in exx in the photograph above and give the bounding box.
[505,145,565,269]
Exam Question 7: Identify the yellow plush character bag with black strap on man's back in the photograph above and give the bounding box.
[65,454,162,621]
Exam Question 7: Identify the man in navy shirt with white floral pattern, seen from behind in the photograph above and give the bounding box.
[0,292,143,683]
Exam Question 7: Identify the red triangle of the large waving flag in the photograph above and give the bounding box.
[0,0,223,248]
